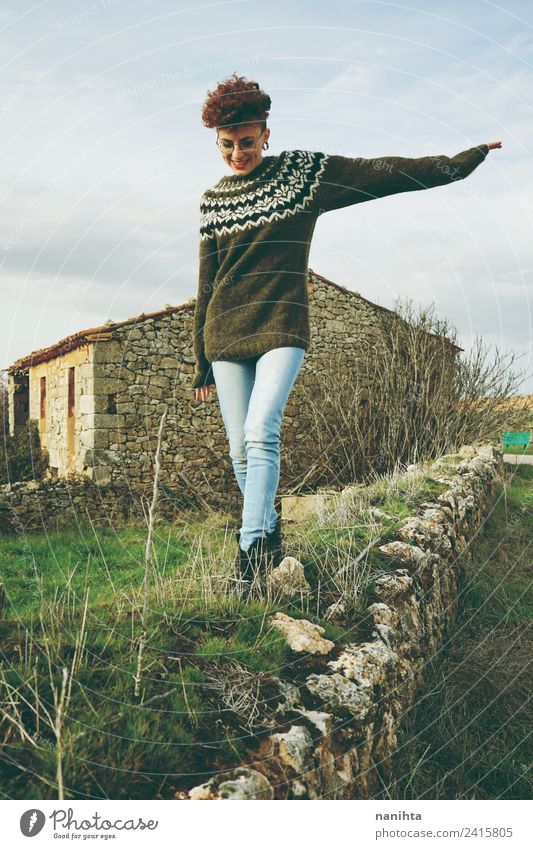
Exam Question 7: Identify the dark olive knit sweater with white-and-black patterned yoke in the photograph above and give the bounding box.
[192,144,489,388]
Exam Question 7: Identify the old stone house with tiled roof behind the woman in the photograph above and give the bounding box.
[8,269,461,501]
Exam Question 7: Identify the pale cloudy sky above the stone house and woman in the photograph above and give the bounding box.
[0,0,533,393]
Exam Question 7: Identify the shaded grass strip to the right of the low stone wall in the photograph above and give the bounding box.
[381,465,533,799]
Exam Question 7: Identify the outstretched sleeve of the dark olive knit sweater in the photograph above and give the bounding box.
[313,144,489,215]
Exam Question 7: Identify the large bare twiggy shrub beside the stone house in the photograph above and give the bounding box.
[283,299,525,492]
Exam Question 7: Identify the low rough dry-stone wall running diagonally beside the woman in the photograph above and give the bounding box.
[183,445,503,799]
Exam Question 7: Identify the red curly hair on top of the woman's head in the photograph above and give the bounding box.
[202,71,272,130]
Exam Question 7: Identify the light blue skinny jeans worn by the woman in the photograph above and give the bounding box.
[211,346,305,551]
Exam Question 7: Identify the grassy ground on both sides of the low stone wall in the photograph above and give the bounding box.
[0,460,533,799]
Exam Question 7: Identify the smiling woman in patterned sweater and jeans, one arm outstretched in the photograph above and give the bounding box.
[192,74,501,588]
